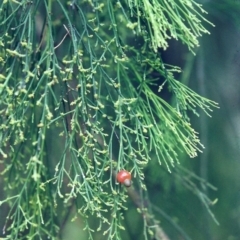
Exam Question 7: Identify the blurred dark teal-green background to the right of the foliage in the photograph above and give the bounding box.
[155,0,240,240]
